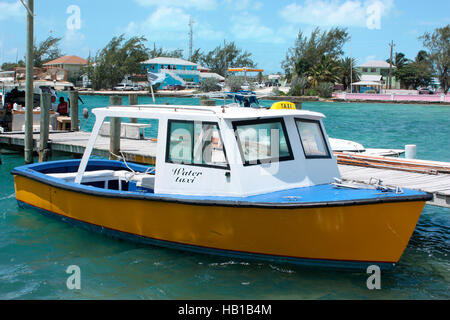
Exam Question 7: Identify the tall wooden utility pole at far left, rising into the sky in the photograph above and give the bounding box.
[22,0,34,164]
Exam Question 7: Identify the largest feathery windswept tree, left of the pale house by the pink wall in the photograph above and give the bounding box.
[281,27,349,81]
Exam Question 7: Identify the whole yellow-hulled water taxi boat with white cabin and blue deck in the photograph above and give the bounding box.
[12,105,431,269]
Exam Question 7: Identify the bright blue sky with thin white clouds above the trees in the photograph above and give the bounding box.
[0,0,450,73]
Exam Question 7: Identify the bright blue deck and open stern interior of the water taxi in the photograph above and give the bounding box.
[13,159,430,208]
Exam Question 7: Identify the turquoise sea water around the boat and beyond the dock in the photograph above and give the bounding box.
[0,96,450,299]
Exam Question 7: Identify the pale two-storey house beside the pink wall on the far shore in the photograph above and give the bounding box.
[353,60,400,93]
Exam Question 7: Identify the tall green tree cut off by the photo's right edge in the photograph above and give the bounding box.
[419,24,450,94]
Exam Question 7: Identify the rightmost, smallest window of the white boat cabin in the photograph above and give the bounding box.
[295,119,331,159]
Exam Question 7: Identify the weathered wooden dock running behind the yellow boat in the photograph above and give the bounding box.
[0,131,450,208]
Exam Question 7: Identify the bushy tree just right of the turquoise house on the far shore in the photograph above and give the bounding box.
[199,42,256,77]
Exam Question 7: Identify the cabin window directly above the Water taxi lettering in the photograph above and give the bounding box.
[166,120,229,169]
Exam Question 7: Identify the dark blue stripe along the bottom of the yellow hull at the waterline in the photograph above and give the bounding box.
[17,201,395,271]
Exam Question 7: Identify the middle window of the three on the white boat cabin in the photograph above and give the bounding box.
[233,118,294,166]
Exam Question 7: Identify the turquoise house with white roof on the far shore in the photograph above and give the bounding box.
[141,57,200,89]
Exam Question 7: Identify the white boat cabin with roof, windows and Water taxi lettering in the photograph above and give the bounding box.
[75,105,340,197]
